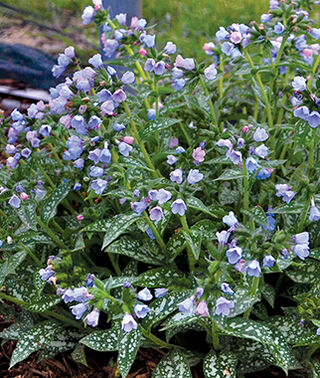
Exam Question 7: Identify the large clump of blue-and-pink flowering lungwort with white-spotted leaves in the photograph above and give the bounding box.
[0,0,320,377]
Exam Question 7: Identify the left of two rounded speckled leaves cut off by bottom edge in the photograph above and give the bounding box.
[152,350,192,378]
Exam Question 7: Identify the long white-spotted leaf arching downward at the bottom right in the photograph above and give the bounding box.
[215,317,292,374]
